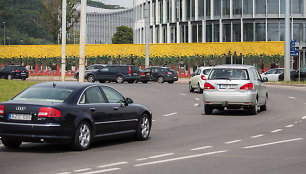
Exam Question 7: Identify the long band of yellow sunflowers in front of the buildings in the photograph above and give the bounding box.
[0,42,284,58]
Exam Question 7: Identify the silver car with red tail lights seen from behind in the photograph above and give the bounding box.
[203,65,268,115]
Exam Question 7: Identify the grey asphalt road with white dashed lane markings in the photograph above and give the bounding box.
[0,83,306,174]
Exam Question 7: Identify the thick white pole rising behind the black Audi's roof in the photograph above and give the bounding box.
[79,0,87,82]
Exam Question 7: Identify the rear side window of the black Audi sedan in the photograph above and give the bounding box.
[80,86,105,104]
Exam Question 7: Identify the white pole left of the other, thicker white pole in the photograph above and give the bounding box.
[61,0,67,81]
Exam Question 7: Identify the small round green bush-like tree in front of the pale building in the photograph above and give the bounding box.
[112,25,133,44]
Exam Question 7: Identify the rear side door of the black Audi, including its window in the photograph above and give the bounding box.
[79,86,113,136]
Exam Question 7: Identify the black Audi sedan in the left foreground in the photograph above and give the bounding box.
[0,82,152,150]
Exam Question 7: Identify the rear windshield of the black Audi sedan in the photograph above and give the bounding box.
[13,87,72,102]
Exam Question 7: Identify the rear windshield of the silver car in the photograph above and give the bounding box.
[208,69,249,80]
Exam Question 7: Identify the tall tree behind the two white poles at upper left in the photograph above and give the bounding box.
[40,0,80,43]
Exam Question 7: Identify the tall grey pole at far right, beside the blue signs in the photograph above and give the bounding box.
[284,0,290,81]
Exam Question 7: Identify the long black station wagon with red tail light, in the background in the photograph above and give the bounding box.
[85,65,140,83]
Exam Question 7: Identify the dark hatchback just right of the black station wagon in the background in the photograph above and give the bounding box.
[146,67,178,83]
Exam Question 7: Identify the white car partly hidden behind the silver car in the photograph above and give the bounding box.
[189,67,212,93]
